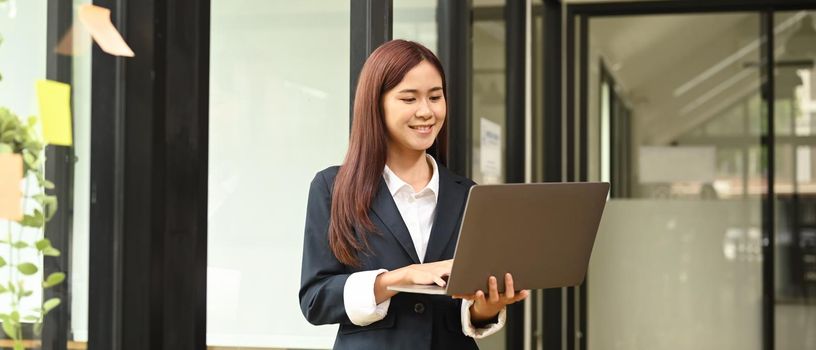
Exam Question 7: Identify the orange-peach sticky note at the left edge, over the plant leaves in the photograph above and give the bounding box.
[0,153,23,221]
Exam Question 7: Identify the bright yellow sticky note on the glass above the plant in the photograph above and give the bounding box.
[37,80,72,146]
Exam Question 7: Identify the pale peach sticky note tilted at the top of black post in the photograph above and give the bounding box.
[79,4,133,57]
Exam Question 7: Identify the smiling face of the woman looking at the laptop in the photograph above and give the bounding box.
[382,61,448,151]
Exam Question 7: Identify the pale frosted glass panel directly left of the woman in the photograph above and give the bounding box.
[207,0,350,348]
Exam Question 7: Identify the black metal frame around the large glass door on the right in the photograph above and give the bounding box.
[566,0,816,350]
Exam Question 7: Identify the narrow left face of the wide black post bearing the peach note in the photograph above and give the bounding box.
[88,0,126,350]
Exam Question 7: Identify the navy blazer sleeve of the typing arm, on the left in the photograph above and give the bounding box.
[299,172,351,325]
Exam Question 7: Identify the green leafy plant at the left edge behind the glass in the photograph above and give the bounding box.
[0,11,65,350]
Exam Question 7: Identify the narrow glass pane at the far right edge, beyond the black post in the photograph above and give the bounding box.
[774,11,816,350]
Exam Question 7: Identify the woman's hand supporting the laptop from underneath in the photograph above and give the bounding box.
[453,273,530,322]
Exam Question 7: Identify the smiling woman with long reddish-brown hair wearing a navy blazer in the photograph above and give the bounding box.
[300,40,529,349]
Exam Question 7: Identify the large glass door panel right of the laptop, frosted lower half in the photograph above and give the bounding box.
[583,13,768,350]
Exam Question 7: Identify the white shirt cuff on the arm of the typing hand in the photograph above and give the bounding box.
[343,269,391,327]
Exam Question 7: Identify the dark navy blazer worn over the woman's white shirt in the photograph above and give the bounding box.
[299,161,478,350]
